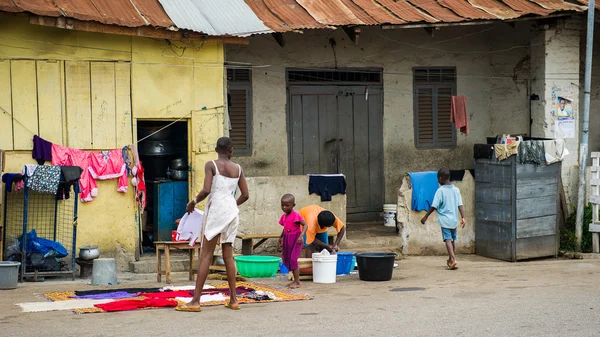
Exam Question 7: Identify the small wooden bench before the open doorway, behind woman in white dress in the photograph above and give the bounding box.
[154,241,239,283]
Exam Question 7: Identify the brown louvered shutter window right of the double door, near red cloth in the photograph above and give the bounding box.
[413,68,456,149]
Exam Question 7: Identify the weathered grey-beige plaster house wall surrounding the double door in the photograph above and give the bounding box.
[227,23,530,203]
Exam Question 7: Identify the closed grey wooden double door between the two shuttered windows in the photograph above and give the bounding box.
[288,86,384,221]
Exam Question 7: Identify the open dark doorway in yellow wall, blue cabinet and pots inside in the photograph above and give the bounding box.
[137,120,190,251]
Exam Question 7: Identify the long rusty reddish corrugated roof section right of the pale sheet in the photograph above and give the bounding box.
[245,0,584,32]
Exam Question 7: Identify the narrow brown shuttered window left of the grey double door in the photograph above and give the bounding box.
[227,69,252,156]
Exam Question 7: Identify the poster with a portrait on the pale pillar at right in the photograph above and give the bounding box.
[551,87,577,139]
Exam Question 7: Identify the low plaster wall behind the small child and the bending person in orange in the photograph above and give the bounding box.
[237,176,346,249]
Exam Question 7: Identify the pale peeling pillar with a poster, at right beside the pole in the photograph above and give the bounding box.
[531,18,583,205]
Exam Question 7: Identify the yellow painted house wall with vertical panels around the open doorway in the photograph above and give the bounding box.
[0,17,225,268]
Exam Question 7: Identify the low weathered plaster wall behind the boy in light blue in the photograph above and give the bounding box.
[398,171,475,255]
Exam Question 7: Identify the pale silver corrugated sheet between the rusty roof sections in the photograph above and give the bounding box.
[159,0,273,36]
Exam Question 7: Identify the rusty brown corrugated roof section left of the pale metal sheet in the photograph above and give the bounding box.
[0,0,174,28]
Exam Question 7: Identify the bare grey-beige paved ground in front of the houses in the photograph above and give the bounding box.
[0,256,600,337]
